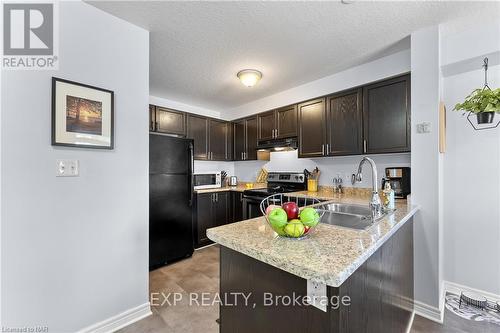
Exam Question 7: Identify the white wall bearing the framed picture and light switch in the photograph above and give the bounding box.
[1,2,149,332]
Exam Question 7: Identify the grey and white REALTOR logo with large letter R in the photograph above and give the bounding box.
[2,2,57,69]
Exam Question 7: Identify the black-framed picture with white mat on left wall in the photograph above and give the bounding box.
[52,77,114,149]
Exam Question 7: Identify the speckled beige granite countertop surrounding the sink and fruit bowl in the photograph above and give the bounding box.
[207,189,418,287]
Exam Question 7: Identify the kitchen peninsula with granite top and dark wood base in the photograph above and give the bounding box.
[207,192,418,333]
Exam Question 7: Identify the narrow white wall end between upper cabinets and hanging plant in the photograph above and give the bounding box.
[411,26,441,311]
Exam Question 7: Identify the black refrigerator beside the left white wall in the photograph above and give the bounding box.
[149,134,194,270]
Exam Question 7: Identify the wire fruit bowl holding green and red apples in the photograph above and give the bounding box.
[260,193,324,239]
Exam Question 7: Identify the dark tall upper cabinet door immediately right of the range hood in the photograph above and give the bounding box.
[297,98,325,157]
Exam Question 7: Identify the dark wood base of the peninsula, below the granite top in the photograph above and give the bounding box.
[220,221,413,333]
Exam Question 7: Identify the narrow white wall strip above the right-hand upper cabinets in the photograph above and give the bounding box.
[222,50,410,119]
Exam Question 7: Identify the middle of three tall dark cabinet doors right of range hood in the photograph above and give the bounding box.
[326,89,363,155]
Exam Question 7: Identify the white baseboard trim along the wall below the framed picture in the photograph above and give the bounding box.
[78,302,152,333]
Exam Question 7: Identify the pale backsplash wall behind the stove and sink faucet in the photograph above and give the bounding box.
[234,150,411,187]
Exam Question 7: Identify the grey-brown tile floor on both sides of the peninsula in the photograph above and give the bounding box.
[118,246,500,333]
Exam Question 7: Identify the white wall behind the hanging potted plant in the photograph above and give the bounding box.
[441,16,500,295]
